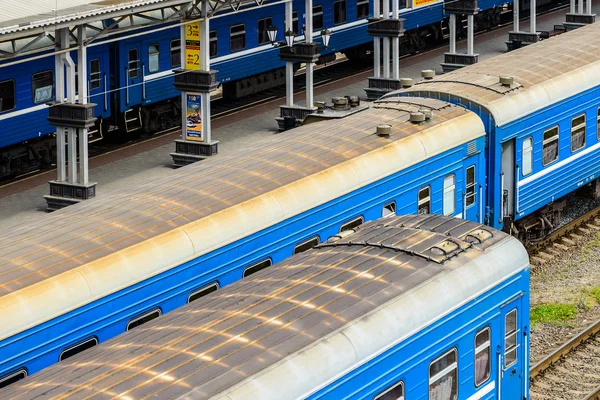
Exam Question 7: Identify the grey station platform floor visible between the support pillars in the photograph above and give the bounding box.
[0,7,584,231]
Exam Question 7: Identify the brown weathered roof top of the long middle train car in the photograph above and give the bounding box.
[0,101,467,297]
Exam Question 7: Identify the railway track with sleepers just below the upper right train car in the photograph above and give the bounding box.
[527,207,600,268]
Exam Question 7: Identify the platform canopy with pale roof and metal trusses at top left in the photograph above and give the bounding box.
[0,0,280,61]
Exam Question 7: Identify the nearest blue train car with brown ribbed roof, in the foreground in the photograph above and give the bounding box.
[0,215,529,400]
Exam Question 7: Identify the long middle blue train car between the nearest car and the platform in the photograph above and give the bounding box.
[0,99,485,385]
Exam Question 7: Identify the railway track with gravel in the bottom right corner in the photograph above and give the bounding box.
[529,320,600,400]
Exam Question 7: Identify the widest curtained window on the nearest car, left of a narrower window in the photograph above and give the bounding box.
[429,349,458,400]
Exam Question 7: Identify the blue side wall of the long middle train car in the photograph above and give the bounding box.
[0,130,484,377]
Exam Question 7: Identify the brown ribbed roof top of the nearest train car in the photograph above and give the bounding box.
[0,215,508,400]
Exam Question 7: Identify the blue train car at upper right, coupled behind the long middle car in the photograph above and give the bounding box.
[387,21,600,240]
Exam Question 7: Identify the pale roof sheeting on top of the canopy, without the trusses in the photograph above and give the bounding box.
[0,0,186,39]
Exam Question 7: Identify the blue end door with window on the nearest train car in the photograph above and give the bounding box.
[496,296,524,400]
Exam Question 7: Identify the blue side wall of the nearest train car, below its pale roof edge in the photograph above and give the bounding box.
[308,262,529,400]
